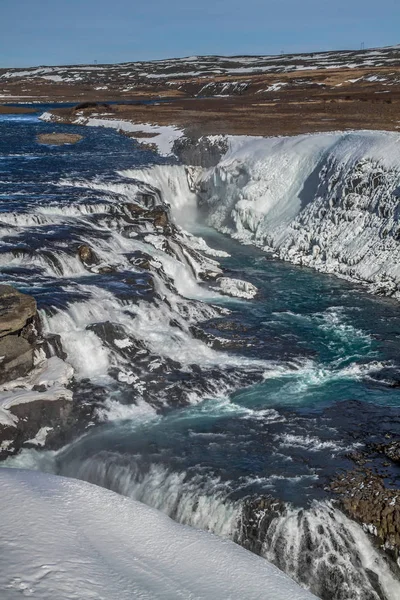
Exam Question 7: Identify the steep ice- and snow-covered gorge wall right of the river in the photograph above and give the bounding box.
[197,131,400,298]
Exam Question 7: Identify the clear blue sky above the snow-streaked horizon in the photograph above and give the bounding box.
[0,0,400,67]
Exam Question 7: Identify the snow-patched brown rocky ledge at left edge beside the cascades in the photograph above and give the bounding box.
[0,285,89,459]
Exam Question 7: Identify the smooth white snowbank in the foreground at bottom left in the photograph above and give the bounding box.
[0,468,315,600]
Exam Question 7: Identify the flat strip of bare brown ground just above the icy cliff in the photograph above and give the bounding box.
[47,89,400,137]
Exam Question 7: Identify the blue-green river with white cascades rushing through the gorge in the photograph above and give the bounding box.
[0,109,400,600]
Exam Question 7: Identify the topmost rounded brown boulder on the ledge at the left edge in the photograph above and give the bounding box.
[0,285,36,338]
